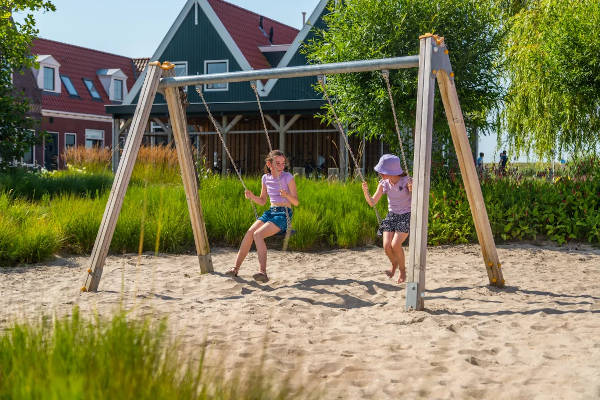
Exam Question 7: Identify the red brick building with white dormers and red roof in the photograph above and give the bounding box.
[31,38,136,169]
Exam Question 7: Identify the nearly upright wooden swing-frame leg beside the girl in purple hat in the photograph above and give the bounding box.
[406,37,435,310]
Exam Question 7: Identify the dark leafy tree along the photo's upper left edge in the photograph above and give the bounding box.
[0,0,55,167]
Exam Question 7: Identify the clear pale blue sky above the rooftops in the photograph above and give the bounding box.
[16,0,512,162]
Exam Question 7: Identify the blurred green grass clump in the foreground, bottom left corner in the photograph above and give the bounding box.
[0,309,314,400]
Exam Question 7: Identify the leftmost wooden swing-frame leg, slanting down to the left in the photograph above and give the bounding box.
[82,61,162,291]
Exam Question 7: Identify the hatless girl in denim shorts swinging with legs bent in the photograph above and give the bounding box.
[227,150,298,282]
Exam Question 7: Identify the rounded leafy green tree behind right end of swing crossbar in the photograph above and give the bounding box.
[305,0,504,165]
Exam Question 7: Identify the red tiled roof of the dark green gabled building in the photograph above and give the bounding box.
[208,0,299,69]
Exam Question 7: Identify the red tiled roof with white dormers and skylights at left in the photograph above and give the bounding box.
[31,38,135,115]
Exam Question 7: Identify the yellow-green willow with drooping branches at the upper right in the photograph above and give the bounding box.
[504,0,600,158]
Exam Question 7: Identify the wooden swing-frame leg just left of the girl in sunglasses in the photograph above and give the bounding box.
[165,76,213,274]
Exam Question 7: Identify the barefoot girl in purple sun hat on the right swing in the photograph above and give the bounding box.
[363,154,412,283]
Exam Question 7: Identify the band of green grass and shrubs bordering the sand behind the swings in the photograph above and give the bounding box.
[0,170,600,266]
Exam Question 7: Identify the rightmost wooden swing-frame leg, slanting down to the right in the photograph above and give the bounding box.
[437,70,504,287]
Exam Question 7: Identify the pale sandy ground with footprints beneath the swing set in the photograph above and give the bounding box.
[0,244,600,399]
